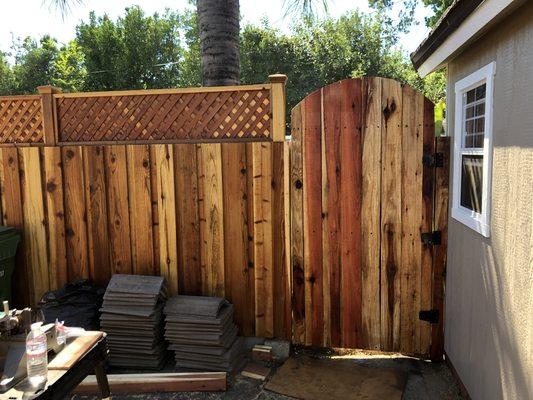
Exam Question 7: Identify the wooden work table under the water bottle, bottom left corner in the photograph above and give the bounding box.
[0,332,110,400]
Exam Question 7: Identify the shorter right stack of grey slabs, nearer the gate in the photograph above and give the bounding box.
[164,296,244,372]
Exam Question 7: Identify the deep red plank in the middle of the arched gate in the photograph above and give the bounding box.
[340,80,362,347]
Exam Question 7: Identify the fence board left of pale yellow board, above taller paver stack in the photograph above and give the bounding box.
[126,145,154,275]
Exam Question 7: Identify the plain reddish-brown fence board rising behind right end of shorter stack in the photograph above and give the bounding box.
[222,143,254,335]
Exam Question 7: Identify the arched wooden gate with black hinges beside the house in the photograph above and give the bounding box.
[290,78,448,358]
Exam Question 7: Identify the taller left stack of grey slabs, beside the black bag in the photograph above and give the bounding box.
[100,274,167,369]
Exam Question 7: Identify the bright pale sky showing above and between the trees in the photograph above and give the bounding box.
[0,0,429,52]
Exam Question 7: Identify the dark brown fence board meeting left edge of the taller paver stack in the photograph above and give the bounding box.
[83,146,111,286]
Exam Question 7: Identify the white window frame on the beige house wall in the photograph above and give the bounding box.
[452,62,496,237]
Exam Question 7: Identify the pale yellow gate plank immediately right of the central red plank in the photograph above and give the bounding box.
[361,78,383,350]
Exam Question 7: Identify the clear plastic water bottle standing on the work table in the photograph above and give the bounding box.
[26,322,48,386]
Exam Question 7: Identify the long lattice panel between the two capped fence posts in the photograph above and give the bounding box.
[57,88,272,142]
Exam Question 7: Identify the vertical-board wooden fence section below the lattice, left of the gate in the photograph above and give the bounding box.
[0,142,291,338]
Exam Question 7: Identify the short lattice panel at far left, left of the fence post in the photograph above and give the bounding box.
[0,96,44,144]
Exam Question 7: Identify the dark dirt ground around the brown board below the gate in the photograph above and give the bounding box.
[72,349,463,400]
